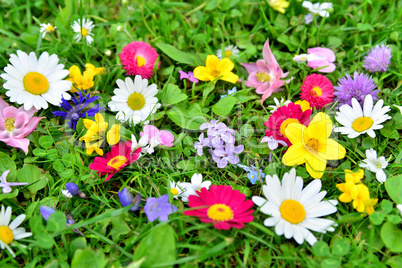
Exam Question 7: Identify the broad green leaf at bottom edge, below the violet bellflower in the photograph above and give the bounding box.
[133,224,176,267]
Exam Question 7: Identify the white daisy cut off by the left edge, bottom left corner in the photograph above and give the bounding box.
[0,205,32,257]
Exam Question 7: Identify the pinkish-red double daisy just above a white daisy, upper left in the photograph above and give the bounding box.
[119,41,159,79]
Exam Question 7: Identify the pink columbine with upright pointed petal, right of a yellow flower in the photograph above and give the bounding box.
[242,39,289,103]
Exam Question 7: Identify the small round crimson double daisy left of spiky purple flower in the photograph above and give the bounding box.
[300,74,334,110]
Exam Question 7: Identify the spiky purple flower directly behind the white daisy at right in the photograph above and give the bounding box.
[334,71,378,106]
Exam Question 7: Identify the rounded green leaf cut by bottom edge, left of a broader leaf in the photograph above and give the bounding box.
[71,248,107,268]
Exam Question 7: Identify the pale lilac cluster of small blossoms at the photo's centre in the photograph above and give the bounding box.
[194,120,244,168]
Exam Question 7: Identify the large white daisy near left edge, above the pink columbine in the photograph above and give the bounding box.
[1,50,72,110]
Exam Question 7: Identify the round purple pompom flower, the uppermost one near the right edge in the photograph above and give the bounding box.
[363,44,392,73]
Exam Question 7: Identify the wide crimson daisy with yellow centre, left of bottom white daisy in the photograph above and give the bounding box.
[184,185,254,230]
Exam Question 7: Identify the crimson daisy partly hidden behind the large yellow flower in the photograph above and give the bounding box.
[264,102,312,146]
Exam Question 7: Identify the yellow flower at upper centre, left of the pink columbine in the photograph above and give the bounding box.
[194,55,239,83]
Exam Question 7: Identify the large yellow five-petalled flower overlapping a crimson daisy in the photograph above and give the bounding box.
[282,112,346,179]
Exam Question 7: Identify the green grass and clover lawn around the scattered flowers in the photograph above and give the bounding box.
[0,0,402,267]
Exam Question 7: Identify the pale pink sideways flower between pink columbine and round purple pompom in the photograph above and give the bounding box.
[293,47,336,73]
